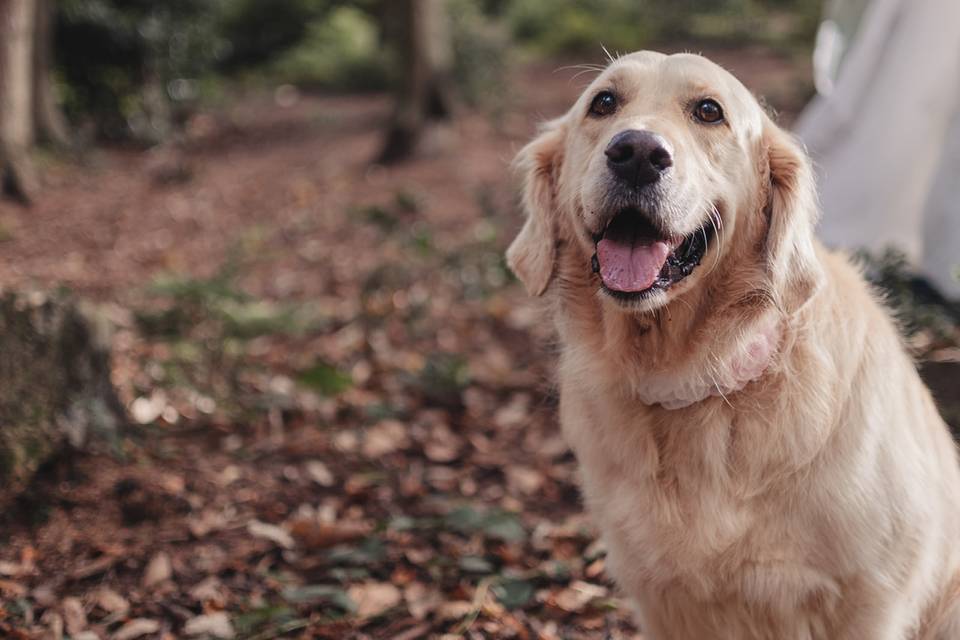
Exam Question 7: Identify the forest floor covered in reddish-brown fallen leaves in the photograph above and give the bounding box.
[0,49,956,640]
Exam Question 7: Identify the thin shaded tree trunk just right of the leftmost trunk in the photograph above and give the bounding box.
[33,0,70,148]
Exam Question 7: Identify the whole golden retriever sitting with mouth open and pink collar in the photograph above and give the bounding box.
[507,51,960,640]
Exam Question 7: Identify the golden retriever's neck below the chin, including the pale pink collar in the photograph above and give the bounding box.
[555,245,785,409]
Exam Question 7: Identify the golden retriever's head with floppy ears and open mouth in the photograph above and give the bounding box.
[507,51,819,312]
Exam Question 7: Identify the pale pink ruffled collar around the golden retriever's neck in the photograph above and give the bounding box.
[639,312,783,409]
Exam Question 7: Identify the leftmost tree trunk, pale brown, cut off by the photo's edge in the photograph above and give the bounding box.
[0,0,36,201]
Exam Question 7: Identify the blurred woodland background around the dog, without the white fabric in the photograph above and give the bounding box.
[0,0,960,640]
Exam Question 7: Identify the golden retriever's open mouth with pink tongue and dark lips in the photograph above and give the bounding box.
[592,208,713,299]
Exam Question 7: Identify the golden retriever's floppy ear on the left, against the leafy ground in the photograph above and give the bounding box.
[507,120,564,296]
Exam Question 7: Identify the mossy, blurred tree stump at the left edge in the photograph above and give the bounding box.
[0,293,125,510]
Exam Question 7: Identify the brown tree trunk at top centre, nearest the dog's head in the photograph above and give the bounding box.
[378,0,453,164]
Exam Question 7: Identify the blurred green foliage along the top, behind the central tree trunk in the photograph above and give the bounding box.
[55,0,821,141]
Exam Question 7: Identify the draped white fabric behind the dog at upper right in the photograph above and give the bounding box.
[796,0,960,297]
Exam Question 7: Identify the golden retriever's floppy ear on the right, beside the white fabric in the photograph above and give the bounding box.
[762,117,823,309]
